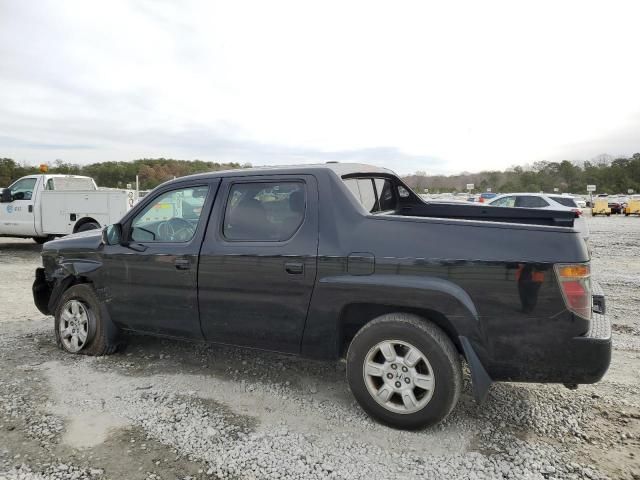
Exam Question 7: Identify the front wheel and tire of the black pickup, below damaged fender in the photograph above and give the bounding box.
[54,283,118,356]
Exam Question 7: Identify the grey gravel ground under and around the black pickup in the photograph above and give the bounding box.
[0,216,640,480]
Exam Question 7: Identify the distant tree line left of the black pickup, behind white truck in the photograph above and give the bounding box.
[0,158,251,190]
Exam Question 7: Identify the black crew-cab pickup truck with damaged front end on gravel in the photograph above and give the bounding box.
[33,164,611,429]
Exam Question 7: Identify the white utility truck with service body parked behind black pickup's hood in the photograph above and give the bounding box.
[0,174,138,243]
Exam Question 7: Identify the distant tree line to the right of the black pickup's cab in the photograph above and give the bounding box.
[404,153,640,195]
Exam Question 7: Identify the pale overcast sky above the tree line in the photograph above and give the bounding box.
[0,0,640,173]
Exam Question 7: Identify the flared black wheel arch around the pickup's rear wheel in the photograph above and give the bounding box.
[301,274,481,359]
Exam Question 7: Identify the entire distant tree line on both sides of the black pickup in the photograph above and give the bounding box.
[0,153,640,194]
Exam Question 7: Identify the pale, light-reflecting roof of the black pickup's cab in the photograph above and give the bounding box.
[176,163,395,180]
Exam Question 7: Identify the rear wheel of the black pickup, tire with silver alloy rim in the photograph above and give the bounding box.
[347,313,462,430]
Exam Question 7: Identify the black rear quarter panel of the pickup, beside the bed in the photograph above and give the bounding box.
[302,185,589,380]
